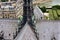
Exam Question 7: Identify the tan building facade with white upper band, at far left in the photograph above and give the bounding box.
[0,0,16,19]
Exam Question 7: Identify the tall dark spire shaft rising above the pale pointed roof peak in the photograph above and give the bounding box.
[23,0,33,25]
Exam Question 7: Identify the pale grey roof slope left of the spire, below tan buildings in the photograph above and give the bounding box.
[0,19,18,40]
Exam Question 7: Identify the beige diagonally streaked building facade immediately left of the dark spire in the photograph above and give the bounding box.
[16,0,23,18]
